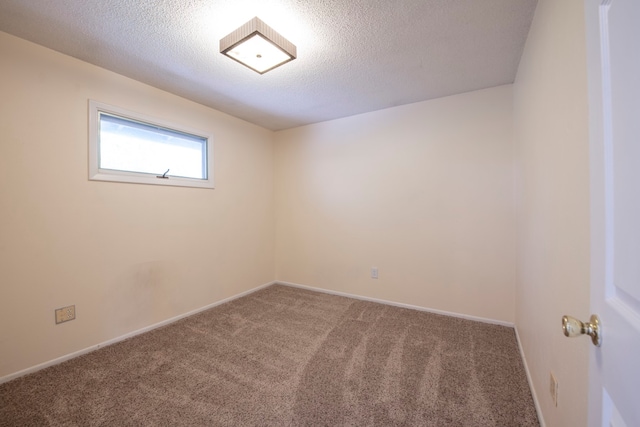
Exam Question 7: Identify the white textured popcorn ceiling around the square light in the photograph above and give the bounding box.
[0,0,536,130]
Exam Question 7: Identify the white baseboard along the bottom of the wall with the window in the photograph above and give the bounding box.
[0,282,276,384]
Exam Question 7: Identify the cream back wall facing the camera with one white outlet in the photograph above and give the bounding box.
[275,85,515,322]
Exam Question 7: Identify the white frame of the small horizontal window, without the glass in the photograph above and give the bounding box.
[89,99,214,188]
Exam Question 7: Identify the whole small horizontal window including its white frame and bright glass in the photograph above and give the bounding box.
[89,101,213,188]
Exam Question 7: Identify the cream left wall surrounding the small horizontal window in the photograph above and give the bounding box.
[0,33,274,377]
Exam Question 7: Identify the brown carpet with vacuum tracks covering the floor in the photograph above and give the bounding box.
[0,285,539,427]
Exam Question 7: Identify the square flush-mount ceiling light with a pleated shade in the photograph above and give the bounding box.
[220,18,296,74]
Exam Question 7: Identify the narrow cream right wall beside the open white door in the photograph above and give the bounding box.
[514,0,591,427]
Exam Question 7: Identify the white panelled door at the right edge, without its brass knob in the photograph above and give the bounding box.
[581,0,640,427]
